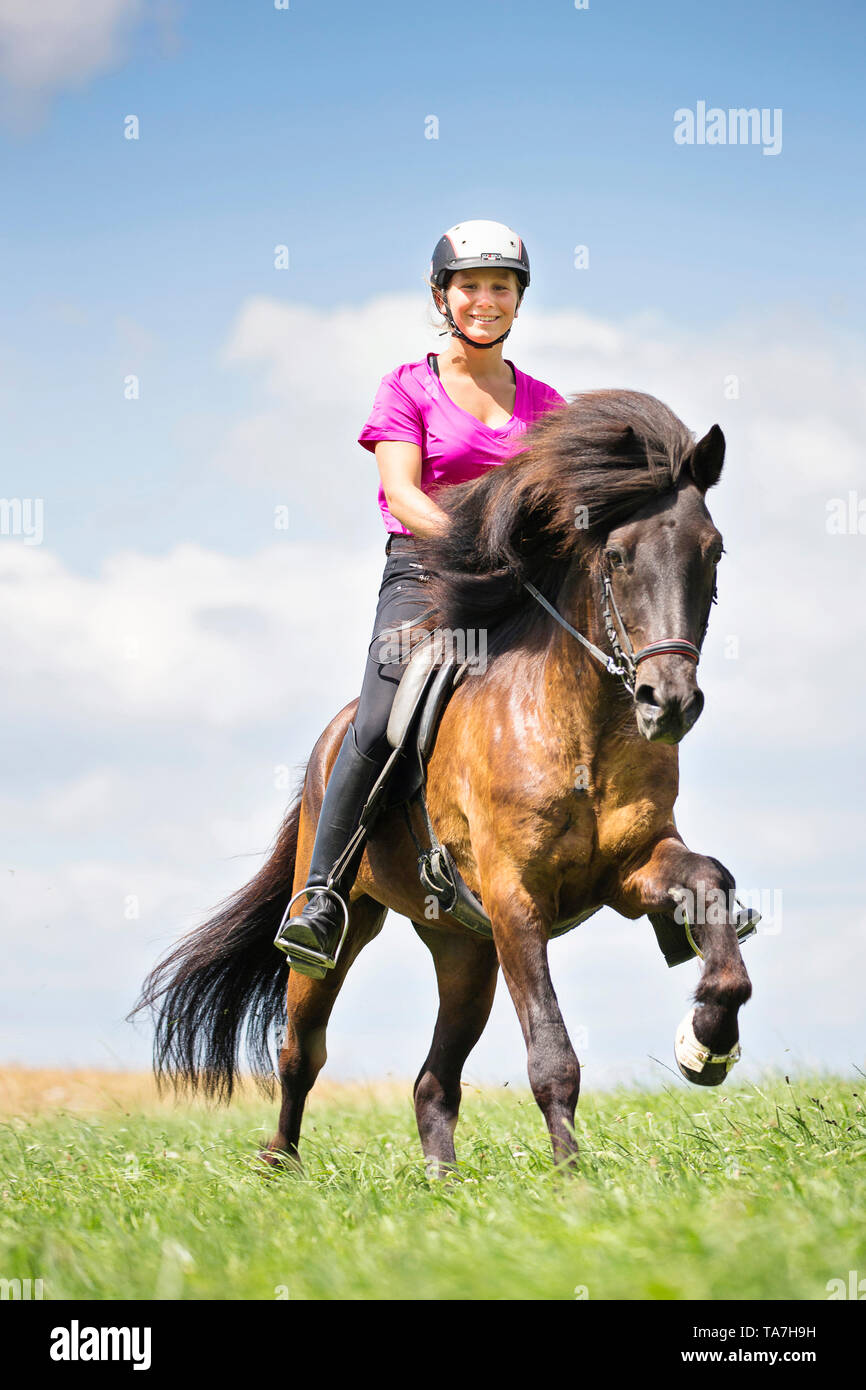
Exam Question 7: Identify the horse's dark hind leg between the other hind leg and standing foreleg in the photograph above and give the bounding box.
[413,922,498,1177]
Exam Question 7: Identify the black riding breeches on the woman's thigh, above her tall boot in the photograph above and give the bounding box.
[353,535,431,765]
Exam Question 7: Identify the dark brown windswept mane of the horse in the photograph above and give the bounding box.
[417,391,695,656]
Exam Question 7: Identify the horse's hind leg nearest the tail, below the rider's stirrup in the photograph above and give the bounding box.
[261,897,388,1163]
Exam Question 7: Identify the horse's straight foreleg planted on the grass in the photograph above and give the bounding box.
[480,865,580,1162]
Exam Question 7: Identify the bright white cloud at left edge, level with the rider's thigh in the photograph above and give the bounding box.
[0,539,382,727]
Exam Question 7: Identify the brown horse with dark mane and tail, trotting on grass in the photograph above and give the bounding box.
[131,391,752,1176]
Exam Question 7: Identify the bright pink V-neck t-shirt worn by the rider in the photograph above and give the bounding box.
[359,357,566,535]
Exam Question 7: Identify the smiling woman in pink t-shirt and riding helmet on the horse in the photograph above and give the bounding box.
[275,221,566,979]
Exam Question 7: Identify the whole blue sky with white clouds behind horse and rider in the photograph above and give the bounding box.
[0,0,866,1076]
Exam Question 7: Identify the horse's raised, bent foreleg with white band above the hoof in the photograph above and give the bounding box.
[613,837,752,1086]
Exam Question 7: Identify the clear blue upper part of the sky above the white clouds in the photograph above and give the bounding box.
[3,0,866,575]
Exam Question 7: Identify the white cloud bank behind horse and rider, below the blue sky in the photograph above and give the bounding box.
[0,296,866,1080]
